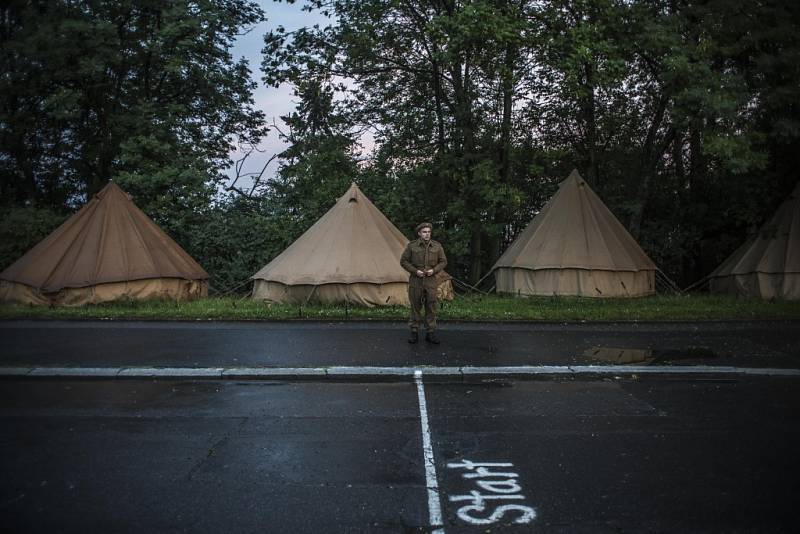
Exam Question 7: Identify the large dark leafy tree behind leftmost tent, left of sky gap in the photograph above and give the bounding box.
[0,0,265,222]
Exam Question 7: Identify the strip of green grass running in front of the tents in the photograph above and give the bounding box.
[0,295,800,321]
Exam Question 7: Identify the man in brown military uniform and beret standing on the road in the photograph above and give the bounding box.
[400,223,447,344]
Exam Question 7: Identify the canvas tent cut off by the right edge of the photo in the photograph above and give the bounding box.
[708,183,800,300]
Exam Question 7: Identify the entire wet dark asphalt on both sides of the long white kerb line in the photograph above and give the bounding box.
[0,321,800,533]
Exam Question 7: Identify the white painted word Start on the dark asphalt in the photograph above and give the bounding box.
[447,460,536,525]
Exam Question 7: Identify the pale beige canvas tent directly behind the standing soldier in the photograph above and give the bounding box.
[252,184,452,306]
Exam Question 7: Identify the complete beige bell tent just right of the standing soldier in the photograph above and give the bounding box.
[492,171,656,297]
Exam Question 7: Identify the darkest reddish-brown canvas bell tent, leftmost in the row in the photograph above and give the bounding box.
[0,182,208,306]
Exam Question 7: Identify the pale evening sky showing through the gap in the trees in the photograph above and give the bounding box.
[228,0,330,195]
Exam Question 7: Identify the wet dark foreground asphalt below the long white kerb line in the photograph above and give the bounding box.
[0,376,800,533]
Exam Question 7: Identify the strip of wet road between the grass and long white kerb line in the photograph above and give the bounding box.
[0,321,800,368]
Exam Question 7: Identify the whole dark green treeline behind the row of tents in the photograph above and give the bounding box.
[0,0,800,294]
